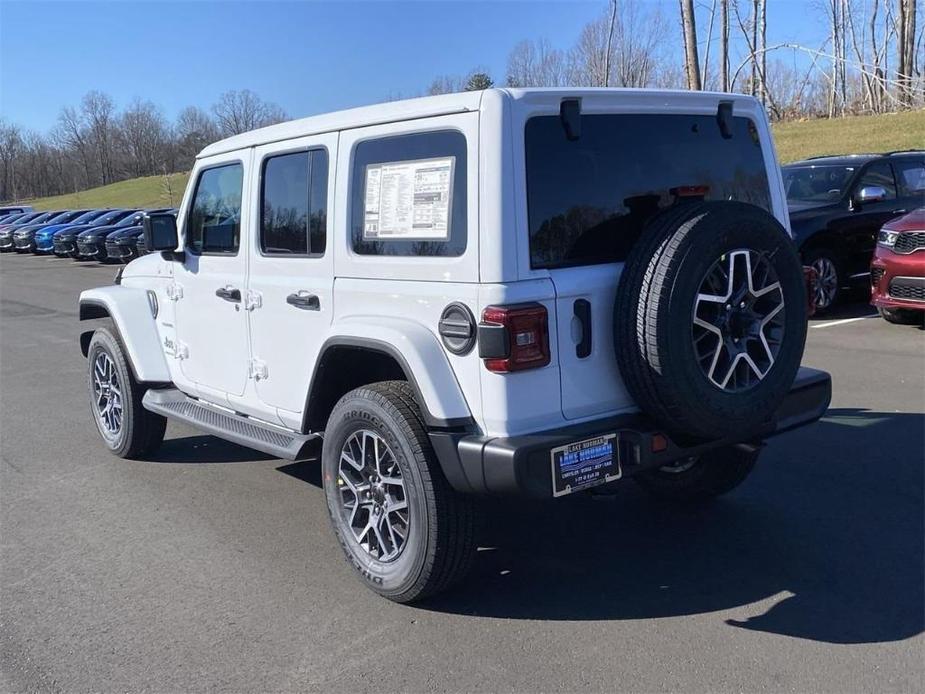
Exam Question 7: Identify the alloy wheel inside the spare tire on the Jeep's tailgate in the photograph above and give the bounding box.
[692,249,786,392]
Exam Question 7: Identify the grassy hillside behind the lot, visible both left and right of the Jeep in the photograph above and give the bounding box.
[19,110,925,210]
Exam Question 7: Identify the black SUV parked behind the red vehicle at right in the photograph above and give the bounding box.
[783,151,925,311]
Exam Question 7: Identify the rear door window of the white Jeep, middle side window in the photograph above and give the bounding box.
[260,149,328,256]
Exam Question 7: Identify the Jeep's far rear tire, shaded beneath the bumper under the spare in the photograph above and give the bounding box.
[633,446,761,502]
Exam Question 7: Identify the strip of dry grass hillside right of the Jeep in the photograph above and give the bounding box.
[771,110,925,164]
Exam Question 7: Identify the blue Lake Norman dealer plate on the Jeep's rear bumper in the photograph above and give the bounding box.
[549,433,623,497]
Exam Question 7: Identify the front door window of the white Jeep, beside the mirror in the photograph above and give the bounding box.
[186,164,244,255]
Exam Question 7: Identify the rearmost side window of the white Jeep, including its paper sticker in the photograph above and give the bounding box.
[350,130,467,257]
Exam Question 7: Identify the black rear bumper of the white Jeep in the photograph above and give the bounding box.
[430,367,832,498]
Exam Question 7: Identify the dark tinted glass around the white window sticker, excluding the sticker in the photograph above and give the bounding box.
[350,131,467,256]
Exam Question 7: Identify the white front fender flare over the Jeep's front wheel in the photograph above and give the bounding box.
[79,285,171,383]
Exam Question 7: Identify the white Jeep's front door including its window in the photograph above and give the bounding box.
[174,152,250,400]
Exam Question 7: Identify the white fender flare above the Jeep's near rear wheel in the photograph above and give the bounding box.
[321,316,472,426]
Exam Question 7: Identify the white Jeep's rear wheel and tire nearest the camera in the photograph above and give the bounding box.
[321,381,475,603]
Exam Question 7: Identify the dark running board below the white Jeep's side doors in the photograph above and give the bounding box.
[141,388,319,460]
